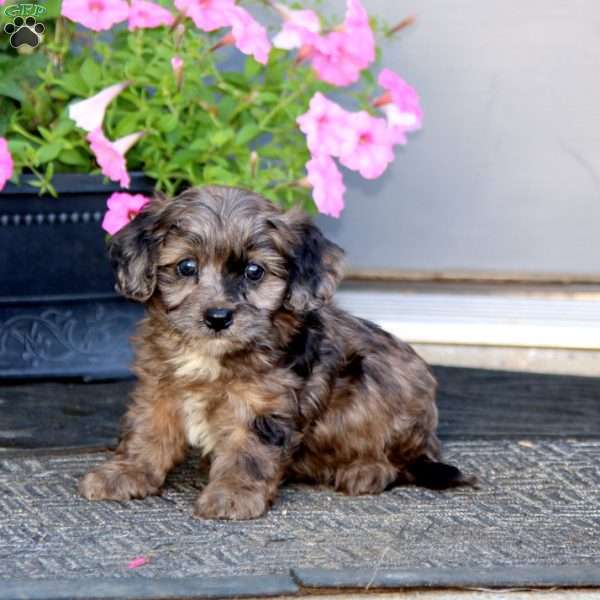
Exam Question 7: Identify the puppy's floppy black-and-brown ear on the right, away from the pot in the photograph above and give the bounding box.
[271,210,344,312]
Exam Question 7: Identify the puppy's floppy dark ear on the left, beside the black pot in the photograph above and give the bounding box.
[108,195,166,302]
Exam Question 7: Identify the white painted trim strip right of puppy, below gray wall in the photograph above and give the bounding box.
[337,289,600,350]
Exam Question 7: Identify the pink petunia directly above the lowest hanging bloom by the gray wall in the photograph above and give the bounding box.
[296,92,356,156]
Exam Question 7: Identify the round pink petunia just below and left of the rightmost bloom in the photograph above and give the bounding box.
[340,110,395,179]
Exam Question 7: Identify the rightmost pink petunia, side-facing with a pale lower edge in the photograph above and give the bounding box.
[374,69,423,143]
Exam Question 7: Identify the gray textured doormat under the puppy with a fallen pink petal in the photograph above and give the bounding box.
[0,439,600,599]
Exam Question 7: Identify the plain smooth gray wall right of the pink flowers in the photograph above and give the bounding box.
[320,0,600,277]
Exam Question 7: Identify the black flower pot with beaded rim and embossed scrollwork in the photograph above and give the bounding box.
[0,175,153,379]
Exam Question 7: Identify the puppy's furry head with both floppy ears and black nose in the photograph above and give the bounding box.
[110,187,343,352]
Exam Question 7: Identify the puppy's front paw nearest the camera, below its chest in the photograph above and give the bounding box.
[194,483,268,520]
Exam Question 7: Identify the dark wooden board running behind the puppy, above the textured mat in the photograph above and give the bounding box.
[0,367,600,452]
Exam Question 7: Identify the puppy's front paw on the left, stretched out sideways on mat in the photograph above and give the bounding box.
[79,463,160,500]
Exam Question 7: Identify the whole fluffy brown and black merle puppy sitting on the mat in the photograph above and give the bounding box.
[79,187,468,519]
